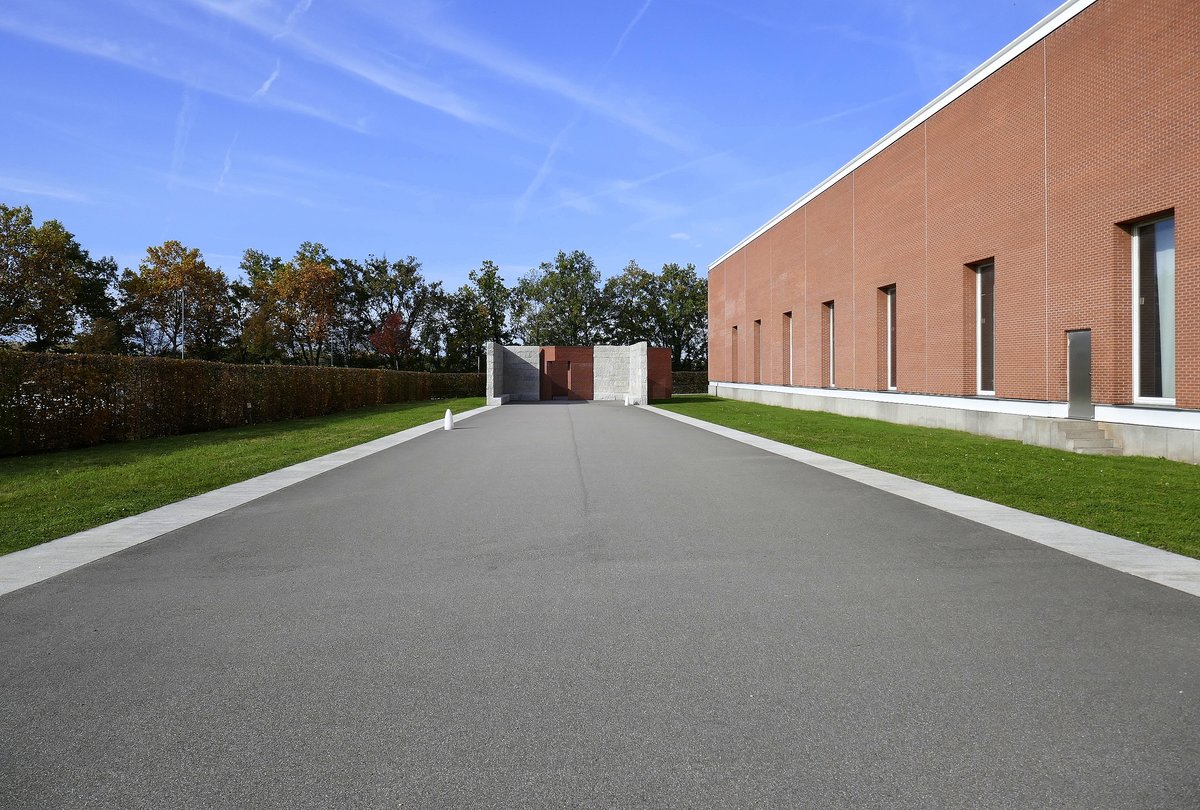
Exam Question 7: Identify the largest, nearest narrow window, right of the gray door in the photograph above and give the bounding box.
[1133,217,1175,404]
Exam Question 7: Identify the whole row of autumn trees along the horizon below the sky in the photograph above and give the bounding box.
[0,204,708,371]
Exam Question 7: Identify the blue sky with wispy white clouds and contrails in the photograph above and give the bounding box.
[0,0,1058,288]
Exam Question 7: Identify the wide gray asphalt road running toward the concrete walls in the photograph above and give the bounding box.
[0,403,1200,808]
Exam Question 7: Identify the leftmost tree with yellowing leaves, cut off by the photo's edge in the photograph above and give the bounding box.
[0,204,89,352]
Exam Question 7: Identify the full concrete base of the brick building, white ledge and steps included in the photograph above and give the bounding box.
[708,383,1200,464]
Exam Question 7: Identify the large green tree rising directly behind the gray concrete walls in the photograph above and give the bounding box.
[514,251,608,346]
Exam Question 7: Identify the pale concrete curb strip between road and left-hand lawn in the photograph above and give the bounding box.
[0,406,499,595]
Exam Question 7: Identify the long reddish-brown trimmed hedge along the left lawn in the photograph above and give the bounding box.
[0,352,484,456]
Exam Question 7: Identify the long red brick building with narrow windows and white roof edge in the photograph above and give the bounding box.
[709,0,1200,461]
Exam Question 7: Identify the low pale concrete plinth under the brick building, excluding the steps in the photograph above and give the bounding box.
[708,383,1200,464]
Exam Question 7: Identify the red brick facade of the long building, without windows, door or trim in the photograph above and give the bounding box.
[709,0,1200,408]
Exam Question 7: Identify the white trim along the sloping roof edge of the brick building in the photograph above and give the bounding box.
[708,0,1096,270]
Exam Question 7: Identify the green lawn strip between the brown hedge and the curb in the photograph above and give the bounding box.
[0,397,484,554]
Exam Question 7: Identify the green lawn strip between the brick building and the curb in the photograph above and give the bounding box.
[654,396,1200,558]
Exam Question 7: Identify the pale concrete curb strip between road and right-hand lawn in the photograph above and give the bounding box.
[638,406,1200,596]
